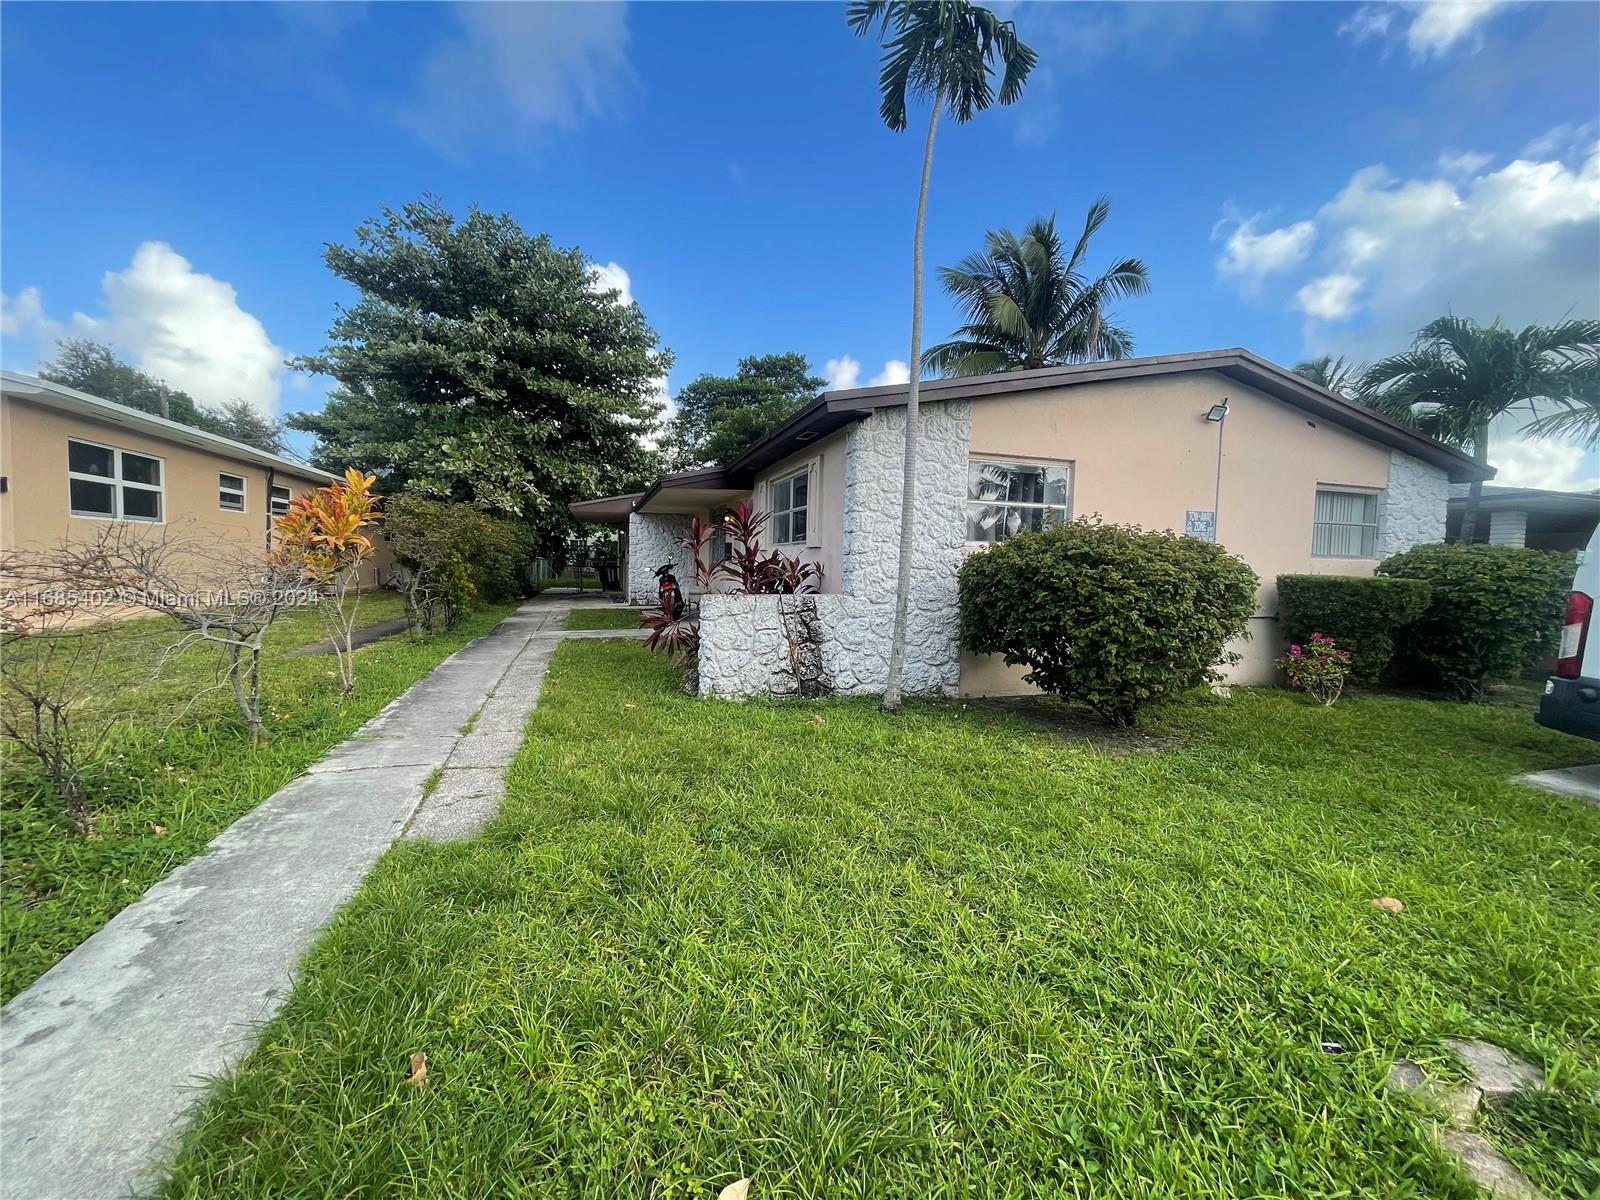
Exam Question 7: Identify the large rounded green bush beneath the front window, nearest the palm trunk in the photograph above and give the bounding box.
[960,520,1258,725]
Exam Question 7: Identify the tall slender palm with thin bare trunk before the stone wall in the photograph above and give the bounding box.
[845,0,1038,712]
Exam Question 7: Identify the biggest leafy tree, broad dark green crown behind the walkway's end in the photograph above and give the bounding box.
[290,197,672,538]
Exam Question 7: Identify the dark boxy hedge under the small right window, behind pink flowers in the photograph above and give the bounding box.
[1278,574,1432,683]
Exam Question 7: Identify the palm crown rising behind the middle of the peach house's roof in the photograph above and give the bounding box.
[922,197,1150,374]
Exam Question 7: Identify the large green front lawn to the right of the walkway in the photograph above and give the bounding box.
[152,640,1600,1200]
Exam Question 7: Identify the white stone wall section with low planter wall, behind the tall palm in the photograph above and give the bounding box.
[699,400,973,696]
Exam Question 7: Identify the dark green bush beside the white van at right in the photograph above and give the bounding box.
[1378,544,1573,699]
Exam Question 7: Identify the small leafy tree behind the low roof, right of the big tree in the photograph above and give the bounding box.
[666,352,827,469]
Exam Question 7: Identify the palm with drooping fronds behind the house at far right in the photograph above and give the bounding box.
[1362,317,1600,542]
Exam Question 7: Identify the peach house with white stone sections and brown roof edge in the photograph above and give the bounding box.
[573,349,1493,696]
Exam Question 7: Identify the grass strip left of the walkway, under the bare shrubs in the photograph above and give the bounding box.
[0,592,509,1000]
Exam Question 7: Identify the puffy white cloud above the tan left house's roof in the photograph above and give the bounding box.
[0,242,285,413]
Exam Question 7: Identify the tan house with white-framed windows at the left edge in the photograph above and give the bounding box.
[0,371,387,582]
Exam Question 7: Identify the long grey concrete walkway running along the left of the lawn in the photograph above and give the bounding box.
[0,595,637,1200]
